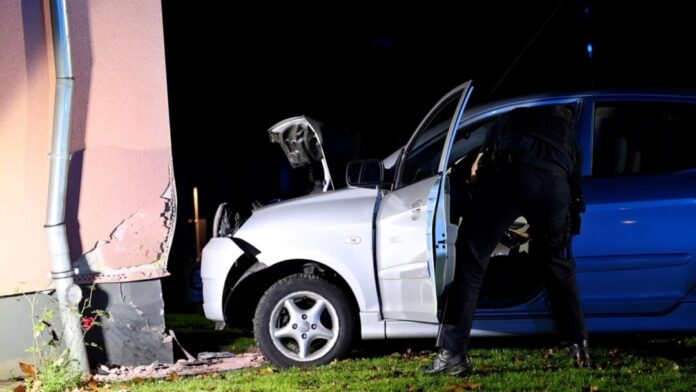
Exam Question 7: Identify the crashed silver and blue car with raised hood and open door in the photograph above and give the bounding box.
[201,82,696,367]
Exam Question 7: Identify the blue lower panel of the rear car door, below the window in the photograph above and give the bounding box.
[575,170,696,315]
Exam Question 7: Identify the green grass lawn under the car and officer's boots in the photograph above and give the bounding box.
[110,316,696,392]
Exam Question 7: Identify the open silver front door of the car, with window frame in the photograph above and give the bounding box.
[375,81,471,323]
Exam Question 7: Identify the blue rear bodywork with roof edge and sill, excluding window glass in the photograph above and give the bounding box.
[464,92,696,334]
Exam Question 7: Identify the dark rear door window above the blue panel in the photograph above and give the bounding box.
[592,102,696,177]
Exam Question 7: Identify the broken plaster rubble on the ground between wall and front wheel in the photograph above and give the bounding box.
[94,352,266,383]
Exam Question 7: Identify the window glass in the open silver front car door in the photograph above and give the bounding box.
[400,94,461,187]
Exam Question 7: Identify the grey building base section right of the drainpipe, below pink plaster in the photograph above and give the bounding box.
[85,280,174,368]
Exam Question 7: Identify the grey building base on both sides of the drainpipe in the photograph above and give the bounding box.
[0,280,174,380]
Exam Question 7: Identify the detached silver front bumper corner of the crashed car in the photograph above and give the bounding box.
[201,237,244,322]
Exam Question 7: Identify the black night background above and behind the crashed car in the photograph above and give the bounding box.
[162,0,696,309]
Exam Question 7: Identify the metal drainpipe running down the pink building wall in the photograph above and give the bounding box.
[44,0,89,373]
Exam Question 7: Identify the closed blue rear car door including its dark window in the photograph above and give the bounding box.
[574,98,696,316]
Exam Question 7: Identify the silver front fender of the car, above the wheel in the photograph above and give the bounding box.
[235,189,379,311]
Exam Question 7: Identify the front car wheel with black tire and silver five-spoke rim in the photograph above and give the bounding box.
[254,274,356,368]
